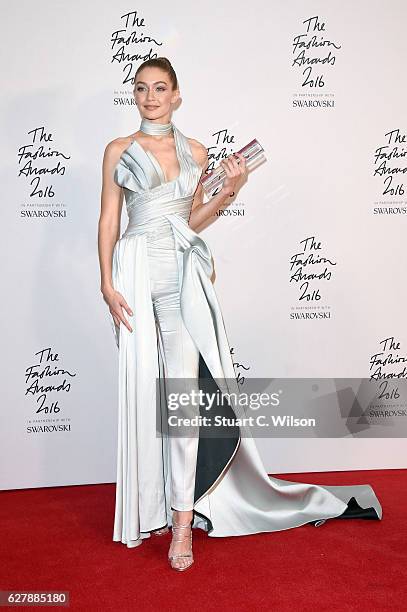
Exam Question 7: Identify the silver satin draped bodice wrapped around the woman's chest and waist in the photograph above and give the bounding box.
[114,124,202,242]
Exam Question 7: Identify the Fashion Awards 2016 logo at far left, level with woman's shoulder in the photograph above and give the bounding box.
[17,126,70,218]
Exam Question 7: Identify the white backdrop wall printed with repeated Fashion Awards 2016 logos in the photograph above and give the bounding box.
[0,0,407,489]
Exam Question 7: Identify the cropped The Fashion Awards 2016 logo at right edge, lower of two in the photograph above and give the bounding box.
[368,336,407,419]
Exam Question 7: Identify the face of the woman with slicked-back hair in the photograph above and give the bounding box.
[134,67,179,121]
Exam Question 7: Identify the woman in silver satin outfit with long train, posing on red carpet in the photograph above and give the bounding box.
[99,58,381,571]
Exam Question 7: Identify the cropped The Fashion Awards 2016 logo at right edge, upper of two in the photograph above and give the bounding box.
[373,128,407,215]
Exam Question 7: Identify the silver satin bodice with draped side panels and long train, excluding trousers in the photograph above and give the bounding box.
[109,123,382,548]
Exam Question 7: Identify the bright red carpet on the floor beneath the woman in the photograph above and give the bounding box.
[0,470,407,612]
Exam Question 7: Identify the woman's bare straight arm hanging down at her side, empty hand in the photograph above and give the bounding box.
[98,139,132,331]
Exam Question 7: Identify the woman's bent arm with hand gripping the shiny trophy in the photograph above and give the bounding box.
[189,143,246,230]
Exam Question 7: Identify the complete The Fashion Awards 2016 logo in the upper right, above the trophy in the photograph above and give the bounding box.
[291,15,342,108]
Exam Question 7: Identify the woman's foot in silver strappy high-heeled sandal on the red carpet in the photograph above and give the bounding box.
[168,510,194,572]
